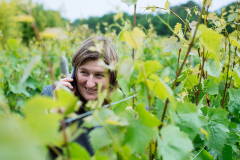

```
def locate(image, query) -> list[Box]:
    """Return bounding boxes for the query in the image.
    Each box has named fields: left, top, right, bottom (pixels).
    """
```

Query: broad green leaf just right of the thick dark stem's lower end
left=173, top=102, right=207, bottom=140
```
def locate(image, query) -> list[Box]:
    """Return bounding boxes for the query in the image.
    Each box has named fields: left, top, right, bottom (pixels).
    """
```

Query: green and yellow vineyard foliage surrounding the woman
left=0, top=0, right=240, bottom=160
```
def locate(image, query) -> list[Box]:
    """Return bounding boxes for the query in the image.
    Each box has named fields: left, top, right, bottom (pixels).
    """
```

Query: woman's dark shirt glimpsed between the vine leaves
left=40, top=85, right=93, bottom=157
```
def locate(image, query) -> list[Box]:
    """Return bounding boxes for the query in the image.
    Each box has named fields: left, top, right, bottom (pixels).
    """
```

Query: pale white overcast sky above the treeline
left=32, top=0, right=237, bottom=21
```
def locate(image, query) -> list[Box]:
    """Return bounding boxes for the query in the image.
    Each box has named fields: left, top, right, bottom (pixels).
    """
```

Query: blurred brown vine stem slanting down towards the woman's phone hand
left=27, top=7, right=55, bottom=88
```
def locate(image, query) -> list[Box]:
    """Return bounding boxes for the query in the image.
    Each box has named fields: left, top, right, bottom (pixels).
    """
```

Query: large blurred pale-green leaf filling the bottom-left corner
left=0, top=115, right=47, bottom=160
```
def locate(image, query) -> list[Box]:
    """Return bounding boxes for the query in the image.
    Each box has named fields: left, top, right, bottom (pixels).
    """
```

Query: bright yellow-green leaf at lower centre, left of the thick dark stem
left=136, top=104, right=161, bottom=127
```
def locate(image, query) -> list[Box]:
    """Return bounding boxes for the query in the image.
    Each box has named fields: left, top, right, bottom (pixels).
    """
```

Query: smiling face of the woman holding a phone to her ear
left=76, top=59, right=109, bottom=101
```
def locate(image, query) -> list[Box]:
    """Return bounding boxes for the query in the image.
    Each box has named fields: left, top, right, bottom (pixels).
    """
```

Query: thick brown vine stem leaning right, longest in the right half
left=158, top=0, right=206, bottom=129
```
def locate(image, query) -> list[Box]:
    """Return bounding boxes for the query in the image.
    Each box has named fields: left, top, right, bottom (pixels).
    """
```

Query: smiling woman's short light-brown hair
left=72, top=36, right=119, bottom=92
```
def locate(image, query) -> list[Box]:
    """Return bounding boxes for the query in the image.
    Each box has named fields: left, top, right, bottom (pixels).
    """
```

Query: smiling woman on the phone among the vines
left=41, top=36, right=119, bottom=155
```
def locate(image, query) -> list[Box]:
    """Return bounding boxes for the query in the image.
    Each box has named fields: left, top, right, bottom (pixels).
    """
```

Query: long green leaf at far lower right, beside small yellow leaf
left=205, top=108, right=229, bottom=152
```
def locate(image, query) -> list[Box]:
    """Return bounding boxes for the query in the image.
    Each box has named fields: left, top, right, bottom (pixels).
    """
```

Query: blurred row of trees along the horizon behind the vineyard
left=0, top=0, right=236, bottom=45
